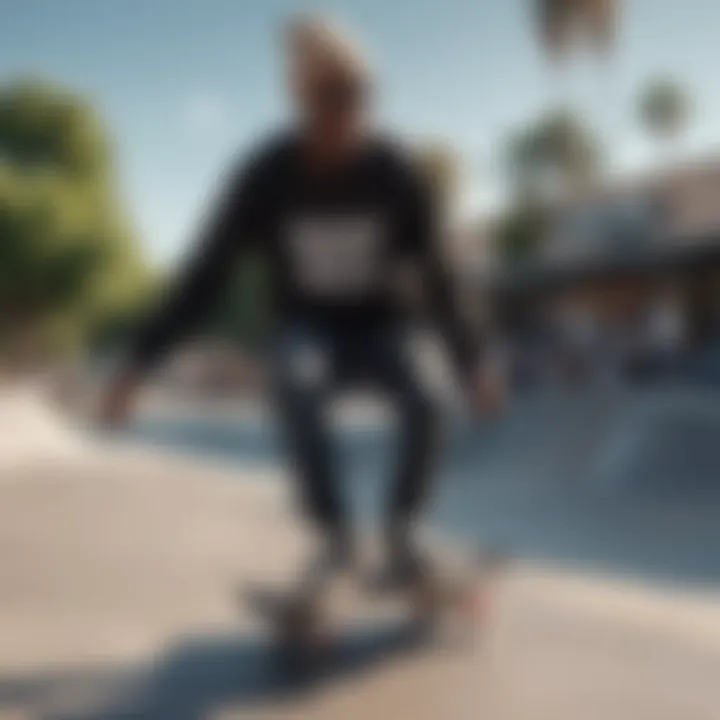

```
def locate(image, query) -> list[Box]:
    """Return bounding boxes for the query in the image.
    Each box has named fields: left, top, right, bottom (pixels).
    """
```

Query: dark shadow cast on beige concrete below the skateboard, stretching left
left=0, top=621, right=436, bottom=720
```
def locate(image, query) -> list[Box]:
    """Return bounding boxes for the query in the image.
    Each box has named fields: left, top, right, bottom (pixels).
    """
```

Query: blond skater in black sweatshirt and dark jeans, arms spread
left=103, top=19, right=500, bottom=596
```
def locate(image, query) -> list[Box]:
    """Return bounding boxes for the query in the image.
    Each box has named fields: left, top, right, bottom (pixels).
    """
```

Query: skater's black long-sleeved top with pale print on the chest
left=132, top=132, right=476, bottom=371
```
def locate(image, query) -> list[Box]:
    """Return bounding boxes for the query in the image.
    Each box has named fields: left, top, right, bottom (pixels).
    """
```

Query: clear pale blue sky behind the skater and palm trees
left=0, top=0, right=720, bottom=262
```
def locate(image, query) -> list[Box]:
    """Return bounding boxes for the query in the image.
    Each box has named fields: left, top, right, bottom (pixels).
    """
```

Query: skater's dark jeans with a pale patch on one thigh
left=275, top=320, right=438, bottom=536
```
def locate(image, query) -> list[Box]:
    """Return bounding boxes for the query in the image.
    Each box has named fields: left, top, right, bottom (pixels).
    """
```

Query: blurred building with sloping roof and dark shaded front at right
left=464, top=158, right=720, bottom=386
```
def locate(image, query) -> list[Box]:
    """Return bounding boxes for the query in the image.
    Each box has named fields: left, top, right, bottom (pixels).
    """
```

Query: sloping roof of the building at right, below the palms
left=464, top=157, right=720, bottom=289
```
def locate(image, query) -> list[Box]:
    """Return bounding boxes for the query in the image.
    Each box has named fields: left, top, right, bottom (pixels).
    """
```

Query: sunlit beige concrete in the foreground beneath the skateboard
left=0, top=449, right=720, bottom=720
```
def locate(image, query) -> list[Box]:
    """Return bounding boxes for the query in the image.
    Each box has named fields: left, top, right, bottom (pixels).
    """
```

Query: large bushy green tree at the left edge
left=0, top=81, right=150, bottom=362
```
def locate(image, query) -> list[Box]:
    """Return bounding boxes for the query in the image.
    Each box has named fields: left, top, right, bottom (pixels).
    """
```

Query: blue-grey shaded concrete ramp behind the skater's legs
left=129, top=386, right=720, bottom=584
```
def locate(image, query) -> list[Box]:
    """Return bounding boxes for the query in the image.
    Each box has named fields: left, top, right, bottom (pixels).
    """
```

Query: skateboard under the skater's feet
left=243, top=549, right=507, bottom=667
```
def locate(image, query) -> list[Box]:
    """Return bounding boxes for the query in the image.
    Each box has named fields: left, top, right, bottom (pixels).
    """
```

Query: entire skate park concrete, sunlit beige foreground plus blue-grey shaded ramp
left=0, top=389, right=720, bottom=720
